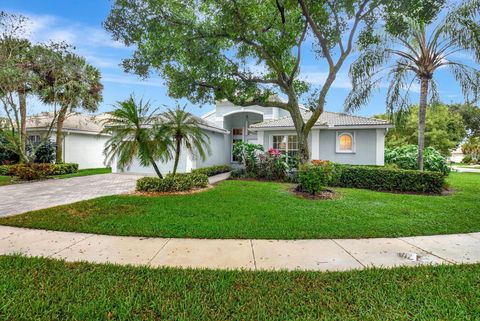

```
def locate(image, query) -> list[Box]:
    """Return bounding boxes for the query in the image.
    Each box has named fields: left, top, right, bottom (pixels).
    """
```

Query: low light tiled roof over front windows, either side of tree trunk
left=250, top=111, right=393, bottom=128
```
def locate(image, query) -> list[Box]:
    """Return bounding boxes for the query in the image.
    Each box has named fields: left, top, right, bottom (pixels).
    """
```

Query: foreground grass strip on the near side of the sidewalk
left=0, top=256, right=480, bottom=320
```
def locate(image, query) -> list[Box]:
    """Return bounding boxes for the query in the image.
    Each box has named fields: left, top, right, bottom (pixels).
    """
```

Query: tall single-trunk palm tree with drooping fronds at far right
left=345, top=0, right=480, bottom=170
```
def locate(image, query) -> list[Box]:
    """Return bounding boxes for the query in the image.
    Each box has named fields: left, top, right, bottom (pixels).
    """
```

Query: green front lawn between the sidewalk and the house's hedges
left=0, top=173, right=480, bottom=239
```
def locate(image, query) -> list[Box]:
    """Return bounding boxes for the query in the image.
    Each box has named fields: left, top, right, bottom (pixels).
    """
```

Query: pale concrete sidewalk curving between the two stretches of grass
left=0, top=226, right=480, bottom=271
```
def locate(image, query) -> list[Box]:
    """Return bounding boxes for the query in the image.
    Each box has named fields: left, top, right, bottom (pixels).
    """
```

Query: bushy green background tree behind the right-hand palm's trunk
left=376, top=104, right=466, bottom=156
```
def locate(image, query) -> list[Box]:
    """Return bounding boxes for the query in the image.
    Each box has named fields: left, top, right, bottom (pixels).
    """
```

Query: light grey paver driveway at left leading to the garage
left=0, top=174, right=140, bottom=216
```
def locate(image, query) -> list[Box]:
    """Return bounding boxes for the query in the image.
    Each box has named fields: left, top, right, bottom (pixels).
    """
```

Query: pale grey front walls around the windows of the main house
left=258, top=128, right=386, bottom=165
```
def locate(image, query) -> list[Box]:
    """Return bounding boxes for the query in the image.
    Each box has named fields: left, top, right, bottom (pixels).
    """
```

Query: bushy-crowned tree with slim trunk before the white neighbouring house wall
left=41, top=51, right=103, bottom=163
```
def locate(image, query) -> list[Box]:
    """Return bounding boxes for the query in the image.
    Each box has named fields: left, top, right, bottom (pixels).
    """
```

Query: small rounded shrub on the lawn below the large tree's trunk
left=298, top=161, right=333, bottom=195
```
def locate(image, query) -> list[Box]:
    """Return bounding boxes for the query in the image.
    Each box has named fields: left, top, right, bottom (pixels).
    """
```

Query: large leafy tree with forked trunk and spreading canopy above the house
left=104, top=0, right=432, bottom=161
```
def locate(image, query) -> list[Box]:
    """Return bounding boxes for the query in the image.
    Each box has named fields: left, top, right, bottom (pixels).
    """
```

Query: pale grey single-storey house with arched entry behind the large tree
left=113, top=101, right=393, bottom=174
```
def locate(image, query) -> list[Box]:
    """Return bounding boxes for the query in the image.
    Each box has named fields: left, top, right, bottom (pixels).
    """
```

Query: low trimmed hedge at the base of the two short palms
left=137, top=173, right=208, bottom=192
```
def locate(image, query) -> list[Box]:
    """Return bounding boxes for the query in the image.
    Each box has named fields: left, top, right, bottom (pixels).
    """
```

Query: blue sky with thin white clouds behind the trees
left=0, top=0, right=472, bottom=116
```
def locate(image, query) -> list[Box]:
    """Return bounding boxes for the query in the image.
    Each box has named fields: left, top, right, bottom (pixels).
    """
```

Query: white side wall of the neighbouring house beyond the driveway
left=63, top=133, right=108, bottom=169
